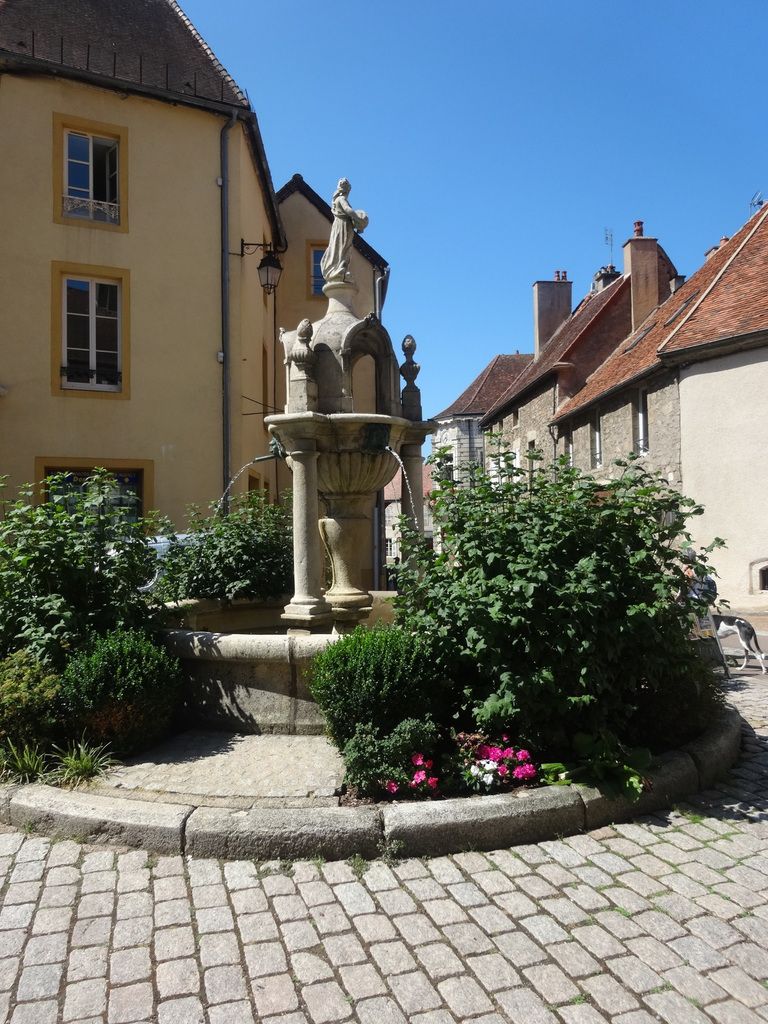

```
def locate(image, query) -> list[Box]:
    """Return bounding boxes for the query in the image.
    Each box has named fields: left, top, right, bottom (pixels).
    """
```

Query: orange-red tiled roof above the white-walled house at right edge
left=555, top=206, right=768, bottom=420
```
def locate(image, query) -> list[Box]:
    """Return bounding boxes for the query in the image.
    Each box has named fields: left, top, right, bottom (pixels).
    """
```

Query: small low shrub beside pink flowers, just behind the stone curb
left=343, top=718, right=437, bottom=796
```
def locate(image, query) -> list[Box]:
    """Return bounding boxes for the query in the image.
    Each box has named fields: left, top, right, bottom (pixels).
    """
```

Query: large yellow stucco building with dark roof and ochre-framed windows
left=0, top=0, right=286, bottom=523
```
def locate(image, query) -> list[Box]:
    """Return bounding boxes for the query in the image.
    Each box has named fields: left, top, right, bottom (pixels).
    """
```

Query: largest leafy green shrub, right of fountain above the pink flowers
left=395, top=451, right=719, bottom=759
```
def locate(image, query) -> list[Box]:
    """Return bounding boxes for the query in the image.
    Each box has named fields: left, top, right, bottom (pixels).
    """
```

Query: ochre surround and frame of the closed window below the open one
left=51, top=260, right=130, bottom=399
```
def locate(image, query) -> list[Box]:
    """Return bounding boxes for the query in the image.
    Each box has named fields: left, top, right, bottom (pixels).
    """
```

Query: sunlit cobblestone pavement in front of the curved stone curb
left=0, top=670, right=768, bottom=1024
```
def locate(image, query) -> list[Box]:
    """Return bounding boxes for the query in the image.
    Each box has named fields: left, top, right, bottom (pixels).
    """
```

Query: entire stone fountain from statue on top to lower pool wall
left=168, top=178, right=436, bottom=734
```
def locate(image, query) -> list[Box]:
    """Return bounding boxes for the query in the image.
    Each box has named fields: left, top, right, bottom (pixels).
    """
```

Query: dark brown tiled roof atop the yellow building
left=0, top=0, right=249, bottom=109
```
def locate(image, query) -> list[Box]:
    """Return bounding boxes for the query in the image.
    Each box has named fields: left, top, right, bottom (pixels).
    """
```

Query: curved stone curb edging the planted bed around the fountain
left=0, top=709, right=742, bottom=860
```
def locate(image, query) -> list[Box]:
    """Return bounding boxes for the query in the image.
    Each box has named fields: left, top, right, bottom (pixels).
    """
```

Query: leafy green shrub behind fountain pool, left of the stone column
left=156, top=490, right=293, bottom=601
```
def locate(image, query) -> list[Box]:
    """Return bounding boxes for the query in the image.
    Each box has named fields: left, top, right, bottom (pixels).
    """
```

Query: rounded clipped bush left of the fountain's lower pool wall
left=61, top=630, right=181, bottom=753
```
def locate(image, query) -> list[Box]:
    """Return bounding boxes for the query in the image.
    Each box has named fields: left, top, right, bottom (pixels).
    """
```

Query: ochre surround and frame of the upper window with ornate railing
left=52, top=113, right=128, bottom=232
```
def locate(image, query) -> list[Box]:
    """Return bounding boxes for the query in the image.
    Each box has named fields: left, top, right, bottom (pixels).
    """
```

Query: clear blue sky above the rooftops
left=181, top=0, right=768, bottom=415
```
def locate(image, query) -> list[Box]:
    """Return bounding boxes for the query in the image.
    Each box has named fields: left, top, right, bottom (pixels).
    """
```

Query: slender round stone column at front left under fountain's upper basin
left=283, top=440, right=331, bottom=628
